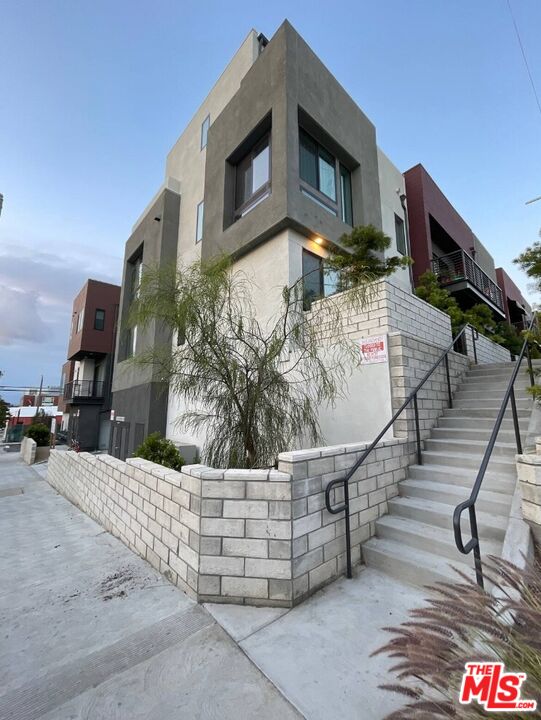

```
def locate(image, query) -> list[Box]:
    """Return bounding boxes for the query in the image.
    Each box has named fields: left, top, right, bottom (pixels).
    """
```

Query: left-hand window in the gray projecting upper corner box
left=235, top=134, right=271, bottom=218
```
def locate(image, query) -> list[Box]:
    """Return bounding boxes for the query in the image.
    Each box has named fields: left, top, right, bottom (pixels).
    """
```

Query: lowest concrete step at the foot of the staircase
left=362, top=538, right=475, bottom=587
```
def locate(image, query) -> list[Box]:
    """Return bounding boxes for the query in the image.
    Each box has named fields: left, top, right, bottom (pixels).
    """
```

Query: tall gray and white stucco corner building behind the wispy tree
left=113, top=21, right=411, bottom=462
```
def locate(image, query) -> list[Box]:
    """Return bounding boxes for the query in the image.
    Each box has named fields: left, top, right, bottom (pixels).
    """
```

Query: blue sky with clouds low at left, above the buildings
left=0, top=0, right=541, bottom=402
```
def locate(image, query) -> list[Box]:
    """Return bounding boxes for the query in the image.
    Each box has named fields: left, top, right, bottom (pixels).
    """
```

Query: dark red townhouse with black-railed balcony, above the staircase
left=404, top=164, right=506, bottom=321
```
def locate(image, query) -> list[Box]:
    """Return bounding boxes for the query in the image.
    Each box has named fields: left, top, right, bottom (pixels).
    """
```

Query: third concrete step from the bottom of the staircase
left=388, top=495, right=508, bottom=542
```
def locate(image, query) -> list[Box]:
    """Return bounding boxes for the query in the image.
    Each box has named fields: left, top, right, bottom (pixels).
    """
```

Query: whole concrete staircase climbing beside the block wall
left=362, top=362, right=532, bottom=585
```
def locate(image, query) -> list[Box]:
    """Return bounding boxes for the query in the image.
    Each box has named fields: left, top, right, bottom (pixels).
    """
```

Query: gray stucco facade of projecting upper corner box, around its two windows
left=202, top=21, right=381, bottom=258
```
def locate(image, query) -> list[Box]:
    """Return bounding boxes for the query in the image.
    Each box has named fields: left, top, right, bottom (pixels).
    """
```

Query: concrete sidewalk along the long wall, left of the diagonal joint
left=0, top=456, right=302, bottom=720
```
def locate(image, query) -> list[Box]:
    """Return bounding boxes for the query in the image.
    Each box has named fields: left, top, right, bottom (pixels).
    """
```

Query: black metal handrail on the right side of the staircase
left=453, top=315, right=536, bottom=587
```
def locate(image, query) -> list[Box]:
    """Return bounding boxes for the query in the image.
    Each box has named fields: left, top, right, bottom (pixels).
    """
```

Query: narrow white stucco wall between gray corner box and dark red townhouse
left=378, top=148, right=411, bottom=291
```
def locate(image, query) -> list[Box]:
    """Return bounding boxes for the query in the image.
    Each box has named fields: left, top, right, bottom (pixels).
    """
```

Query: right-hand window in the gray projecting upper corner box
left=299, top=128, right=353, bottom=225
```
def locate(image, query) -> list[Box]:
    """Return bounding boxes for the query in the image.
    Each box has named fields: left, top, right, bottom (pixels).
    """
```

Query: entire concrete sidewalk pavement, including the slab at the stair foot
left=0, top=453, right=424, bottom=720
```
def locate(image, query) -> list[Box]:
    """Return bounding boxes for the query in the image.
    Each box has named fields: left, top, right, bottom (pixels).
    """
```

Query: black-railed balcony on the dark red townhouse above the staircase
left=432, top=250, right=505, bottom=315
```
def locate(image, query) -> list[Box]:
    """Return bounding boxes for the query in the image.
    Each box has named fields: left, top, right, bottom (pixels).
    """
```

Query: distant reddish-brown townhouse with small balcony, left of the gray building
left=60, top=280, right=120, bottom=451
